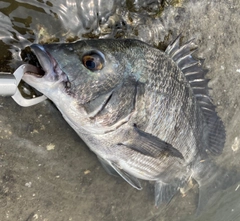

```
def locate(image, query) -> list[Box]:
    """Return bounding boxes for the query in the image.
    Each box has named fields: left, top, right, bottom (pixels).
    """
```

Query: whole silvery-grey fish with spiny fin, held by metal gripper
left=23, top=36, right=228, bottom=210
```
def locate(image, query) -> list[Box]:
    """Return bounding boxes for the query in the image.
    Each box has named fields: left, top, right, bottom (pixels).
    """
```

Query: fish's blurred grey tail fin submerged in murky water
left=194, top=160, right=240, bottom=215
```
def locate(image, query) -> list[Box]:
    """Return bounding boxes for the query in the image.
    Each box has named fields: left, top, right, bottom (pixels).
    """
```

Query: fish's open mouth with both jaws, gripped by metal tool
left=23, top=44, right=68, bottom=96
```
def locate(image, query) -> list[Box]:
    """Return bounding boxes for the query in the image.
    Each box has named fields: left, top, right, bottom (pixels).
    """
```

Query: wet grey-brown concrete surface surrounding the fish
left=0, top=0, right=240, bottom=221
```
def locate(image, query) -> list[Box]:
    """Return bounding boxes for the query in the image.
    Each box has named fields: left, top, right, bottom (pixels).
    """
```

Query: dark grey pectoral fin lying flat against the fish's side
left=118, top=127, right=183, bottom=159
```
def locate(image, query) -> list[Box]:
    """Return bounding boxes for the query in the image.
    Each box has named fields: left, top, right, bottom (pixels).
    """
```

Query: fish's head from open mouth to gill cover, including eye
left=23, top=39, right=144, bottom=133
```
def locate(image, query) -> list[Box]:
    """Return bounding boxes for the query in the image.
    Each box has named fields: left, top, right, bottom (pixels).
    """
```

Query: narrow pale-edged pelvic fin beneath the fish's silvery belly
left=98, top=157, right=142, bottom=190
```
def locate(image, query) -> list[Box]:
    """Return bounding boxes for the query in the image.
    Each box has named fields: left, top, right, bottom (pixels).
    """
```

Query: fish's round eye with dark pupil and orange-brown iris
left=82, top=52, right=104, bottom=71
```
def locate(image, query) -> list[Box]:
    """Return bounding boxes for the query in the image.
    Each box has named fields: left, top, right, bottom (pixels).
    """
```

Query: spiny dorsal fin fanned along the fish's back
left=165, top=35, right=226, bottom=154
